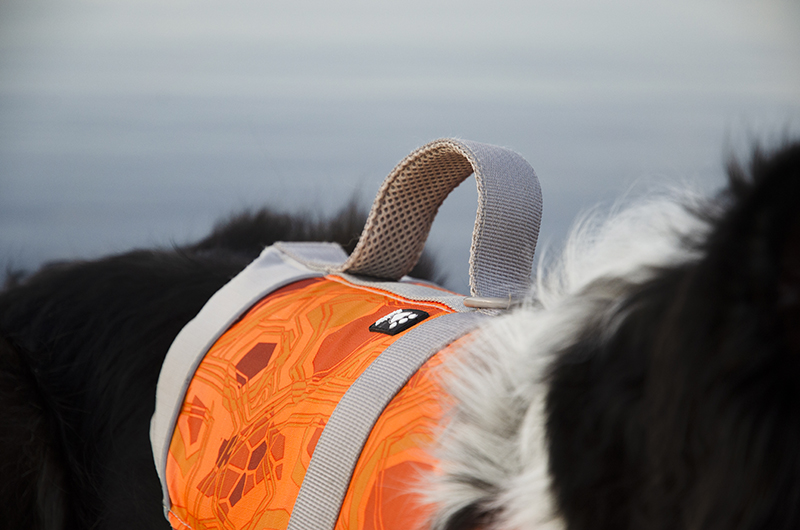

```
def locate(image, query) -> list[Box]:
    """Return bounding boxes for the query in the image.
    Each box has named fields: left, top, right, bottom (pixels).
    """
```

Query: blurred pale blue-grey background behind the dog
left=0, top=0, right=800, bottom=291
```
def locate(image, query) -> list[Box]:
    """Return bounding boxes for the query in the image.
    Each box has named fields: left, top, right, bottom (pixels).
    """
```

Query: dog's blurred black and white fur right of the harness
left=435, top=144, right=800, bottom=530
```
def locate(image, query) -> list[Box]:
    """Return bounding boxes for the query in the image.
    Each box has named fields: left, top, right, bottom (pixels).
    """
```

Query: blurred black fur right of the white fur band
left=547, top=138, right=800, bottom=530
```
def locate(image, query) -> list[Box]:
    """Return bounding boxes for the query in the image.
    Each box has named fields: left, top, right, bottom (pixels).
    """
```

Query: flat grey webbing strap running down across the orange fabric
left=287, top=313, right=482, bottom=530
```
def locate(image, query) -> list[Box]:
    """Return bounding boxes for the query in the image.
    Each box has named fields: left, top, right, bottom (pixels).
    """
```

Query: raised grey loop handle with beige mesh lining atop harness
left=333, top=139, right=542, bottom=298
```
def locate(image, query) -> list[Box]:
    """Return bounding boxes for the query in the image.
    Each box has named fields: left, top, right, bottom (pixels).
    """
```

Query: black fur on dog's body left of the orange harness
left=0, top=204, right=433, bottom=529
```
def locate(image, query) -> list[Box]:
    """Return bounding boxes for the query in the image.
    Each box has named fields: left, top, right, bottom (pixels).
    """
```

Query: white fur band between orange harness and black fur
left=427, top=191, right=707, bottom=530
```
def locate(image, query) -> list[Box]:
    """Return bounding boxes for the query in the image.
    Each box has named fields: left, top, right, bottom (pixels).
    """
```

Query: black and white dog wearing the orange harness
left=0, top=143, right=800, bottom=530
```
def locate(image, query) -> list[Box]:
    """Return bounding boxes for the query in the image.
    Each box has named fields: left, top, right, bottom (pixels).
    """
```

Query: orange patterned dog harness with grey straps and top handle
left=151, top=139, right=541, bottom=530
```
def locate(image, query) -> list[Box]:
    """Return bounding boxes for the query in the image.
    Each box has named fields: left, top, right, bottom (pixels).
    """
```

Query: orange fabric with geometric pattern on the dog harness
left=167, top=276, right=460, bottom=530
